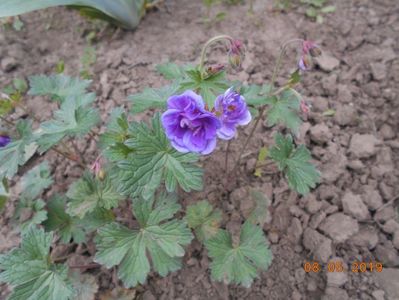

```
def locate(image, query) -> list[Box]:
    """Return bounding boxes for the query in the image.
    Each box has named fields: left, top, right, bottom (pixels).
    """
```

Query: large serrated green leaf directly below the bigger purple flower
left=113, top=114, right=202, bottom=199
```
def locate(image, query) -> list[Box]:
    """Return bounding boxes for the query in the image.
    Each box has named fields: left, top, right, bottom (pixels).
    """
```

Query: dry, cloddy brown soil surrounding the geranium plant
left=0, top=0, right=399, bottom=300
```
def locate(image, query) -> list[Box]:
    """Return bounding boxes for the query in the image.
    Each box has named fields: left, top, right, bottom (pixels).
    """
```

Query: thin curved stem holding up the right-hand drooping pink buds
left=233, top=39, right=304, bottom=172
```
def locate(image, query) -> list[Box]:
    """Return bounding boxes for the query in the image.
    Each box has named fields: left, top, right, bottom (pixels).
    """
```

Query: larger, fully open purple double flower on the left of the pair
left=162, top=91, right=221, bottom=155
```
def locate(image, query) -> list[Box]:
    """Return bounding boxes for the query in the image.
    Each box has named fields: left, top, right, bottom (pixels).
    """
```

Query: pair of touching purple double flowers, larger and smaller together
left=162, top=88, right=251, bottom=155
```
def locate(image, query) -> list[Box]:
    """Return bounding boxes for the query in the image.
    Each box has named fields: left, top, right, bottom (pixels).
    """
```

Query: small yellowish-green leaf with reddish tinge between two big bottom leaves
left=186, top=200, right=222, bottom=241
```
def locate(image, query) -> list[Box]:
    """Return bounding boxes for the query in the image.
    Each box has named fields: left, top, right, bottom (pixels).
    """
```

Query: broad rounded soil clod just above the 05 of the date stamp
left=319, top=213, right=359, bottom=243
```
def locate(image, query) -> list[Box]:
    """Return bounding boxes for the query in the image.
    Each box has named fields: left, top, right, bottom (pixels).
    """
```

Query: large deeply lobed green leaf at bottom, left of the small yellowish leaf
left=95, top=195, right=193, bottom=287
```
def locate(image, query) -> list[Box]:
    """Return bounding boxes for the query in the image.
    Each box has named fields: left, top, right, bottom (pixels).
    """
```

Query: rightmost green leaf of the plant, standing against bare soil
left=270, top=133, right=320, bottom=195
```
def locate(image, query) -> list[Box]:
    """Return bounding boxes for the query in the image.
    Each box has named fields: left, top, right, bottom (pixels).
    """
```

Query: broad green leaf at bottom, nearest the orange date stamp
left=205, top=222, right=272, bottom=287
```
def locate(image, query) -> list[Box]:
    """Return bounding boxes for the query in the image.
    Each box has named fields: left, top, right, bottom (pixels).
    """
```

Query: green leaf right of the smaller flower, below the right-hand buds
left=267, top=89, right=302, bottom=134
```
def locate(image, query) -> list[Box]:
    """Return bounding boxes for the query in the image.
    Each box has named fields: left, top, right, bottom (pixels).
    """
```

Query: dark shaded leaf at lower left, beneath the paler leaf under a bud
left=43, top=195, right=115, bottom=244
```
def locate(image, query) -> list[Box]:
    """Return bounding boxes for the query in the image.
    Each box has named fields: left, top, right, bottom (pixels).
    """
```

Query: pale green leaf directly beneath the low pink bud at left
left=66, top=172, right=123, bottom=218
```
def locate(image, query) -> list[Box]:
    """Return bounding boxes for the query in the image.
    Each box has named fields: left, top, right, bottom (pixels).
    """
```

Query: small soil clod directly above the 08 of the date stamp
left=303, top=227, right=332, bottom=263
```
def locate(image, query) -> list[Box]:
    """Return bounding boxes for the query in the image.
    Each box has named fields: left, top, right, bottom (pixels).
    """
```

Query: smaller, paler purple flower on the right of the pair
left=215, top=88, right=252, bottom=140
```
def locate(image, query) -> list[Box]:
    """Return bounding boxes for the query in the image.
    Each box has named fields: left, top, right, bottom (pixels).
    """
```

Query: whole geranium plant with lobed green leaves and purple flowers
left=0, top=35, right=320, bottom=300
